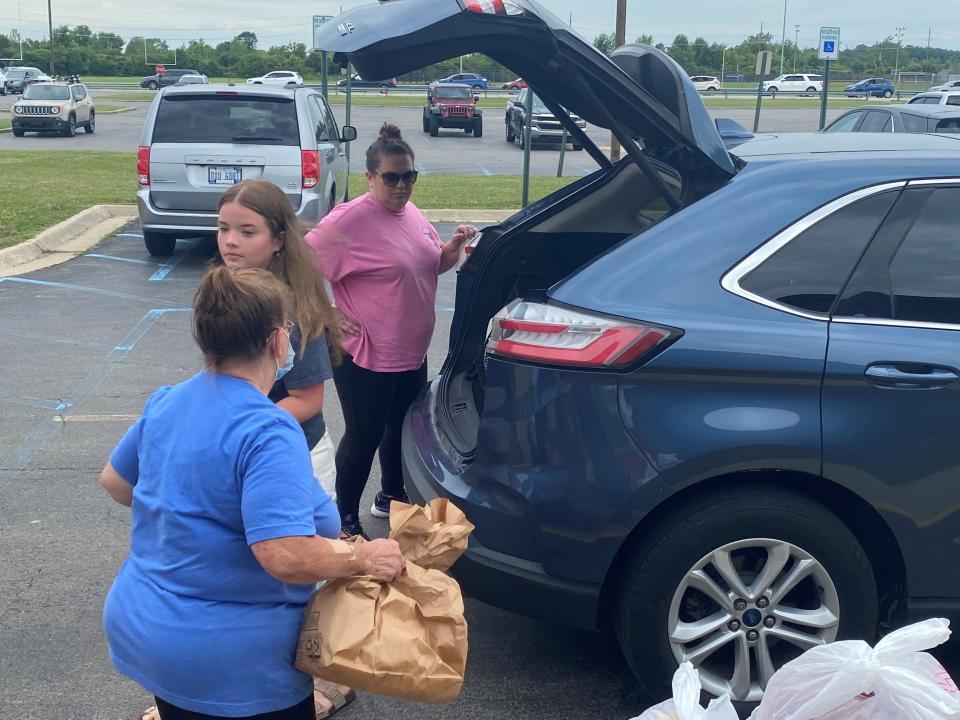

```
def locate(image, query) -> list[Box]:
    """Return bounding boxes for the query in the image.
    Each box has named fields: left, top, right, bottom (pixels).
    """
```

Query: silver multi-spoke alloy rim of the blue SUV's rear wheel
left=667, top=538, right=840, bottom=702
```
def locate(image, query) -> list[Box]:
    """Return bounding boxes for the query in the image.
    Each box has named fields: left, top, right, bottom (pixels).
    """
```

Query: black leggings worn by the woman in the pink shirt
left=333, top=355, right=427, bottom=520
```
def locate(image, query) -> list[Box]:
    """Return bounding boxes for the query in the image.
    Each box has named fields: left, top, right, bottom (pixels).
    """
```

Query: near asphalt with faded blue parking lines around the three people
left=0, top=223, right=644, bottom=720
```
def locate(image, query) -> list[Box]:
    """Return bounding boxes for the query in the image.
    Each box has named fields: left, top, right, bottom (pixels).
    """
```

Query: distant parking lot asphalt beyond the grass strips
left=0, top=90, right=843, bottom=176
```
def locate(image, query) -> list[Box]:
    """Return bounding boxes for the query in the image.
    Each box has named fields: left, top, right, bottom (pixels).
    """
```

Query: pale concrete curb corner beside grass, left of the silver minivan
left=0, top=205, right=137, bottom=276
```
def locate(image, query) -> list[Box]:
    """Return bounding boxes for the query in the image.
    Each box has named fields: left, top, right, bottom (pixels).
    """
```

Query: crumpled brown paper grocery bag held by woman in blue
left=296, top=500, right=473, bottom=703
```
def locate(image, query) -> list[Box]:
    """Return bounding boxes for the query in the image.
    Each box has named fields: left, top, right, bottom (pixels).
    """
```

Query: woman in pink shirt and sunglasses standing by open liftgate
left=307, top=123, right=477, bottom=536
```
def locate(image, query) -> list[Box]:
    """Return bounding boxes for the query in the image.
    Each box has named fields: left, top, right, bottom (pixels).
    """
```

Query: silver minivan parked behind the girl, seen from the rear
left=137, top=84, right=356, bottom=255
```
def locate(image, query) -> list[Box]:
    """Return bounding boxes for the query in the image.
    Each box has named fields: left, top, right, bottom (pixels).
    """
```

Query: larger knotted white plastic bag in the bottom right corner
left=750, top=618, right=960, bottom=720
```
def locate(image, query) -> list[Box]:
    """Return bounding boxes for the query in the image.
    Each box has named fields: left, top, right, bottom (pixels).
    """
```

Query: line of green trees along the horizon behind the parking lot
left=0, top=25, right=960, bottom=84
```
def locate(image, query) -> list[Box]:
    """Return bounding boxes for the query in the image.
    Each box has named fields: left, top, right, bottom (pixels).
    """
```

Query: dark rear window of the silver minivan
left=153, top=95, right=300, bottom=145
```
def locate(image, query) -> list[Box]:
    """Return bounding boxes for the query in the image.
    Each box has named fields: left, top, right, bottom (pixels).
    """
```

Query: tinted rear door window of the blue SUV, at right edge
left=890, top=188, right=960, bottom=324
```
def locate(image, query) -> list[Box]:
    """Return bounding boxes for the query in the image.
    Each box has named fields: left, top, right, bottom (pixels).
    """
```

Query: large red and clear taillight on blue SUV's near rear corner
left=487, top=299, right=681, bottom=368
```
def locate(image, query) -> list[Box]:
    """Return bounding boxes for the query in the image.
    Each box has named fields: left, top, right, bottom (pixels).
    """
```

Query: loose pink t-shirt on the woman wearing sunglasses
left=307, top=193, right=442, bottom=372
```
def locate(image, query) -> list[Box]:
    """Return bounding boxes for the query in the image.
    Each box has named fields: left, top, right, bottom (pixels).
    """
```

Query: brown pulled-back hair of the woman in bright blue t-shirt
left=193, top=265, right=293, bottom=370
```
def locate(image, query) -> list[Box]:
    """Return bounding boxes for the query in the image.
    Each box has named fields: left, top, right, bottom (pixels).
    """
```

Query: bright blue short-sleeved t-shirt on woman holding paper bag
left=103, top=372, right=340, bottom=717
